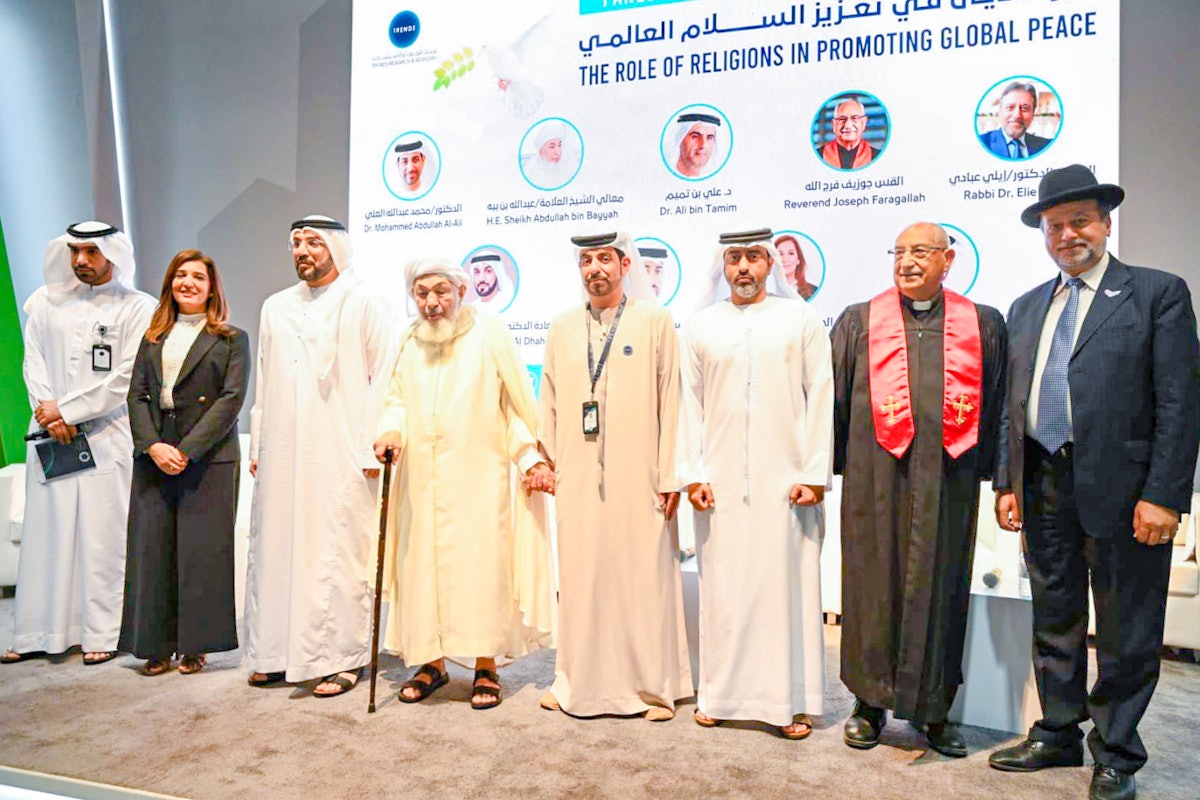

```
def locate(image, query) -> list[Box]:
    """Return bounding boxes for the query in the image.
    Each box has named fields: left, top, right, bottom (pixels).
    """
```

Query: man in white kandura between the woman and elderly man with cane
left=246, top=216, right=392, bottom=697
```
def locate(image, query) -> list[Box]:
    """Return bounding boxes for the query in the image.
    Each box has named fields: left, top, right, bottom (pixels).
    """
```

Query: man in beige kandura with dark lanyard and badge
left=540, top=233, right=692, bottom=721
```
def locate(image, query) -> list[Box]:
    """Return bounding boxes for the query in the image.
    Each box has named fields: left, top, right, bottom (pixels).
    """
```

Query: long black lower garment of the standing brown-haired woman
left=118, top=456, right=238, bottom=658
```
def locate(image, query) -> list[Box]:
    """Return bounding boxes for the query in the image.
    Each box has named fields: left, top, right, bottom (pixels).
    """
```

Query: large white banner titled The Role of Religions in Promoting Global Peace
left=350, top=0, right=1120, bottom=383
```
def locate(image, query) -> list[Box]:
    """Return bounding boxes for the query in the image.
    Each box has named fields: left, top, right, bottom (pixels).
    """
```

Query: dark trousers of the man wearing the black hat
left=1025, top=439, right=1171, bottom=772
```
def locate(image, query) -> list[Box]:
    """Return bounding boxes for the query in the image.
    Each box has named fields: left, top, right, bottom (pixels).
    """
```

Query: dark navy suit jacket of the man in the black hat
left=996, top=257, right=1200, bottom=537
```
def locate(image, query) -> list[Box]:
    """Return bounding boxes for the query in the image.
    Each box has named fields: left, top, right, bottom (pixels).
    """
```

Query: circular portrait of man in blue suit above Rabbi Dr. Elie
left=976, top=76, right=1062, bottom=161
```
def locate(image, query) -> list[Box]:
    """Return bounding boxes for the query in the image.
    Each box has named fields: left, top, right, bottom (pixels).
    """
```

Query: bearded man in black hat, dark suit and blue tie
left=989, top=164, right=1200, bottom=800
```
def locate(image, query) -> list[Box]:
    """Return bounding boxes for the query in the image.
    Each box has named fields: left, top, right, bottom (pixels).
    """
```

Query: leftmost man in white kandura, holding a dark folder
left=0, top=222, right=155, bottom=666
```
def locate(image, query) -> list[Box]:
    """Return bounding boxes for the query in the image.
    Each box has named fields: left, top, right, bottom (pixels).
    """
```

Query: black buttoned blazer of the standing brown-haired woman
left=128, top=327, right=250, bottom=463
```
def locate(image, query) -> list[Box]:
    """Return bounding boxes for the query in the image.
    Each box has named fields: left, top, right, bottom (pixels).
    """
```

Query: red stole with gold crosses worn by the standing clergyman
left=866, top=289, right=983, bottom=458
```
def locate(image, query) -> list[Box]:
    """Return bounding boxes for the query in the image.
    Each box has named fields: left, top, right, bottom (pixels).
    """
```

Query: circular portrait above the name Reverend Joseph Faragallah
left=812, top=91, right=892, bottom=172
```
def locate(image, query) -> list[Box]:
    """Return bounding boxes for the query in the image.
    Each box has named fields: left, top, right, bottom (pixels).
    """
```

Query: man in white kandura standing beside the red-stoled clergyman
left=679, top=229, right=833, bottom=739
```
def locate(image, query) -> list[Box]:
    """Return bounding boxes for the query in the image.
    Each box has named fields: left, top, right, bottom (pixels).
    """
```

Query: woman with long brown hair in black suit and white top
left=119, top=249, right=250, bottom=675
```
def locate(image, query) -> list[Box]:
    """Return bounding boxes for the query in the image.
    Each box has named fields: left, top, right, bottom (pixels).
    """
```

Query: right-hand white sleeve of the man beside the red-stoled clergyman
left=796, top=313, right=833, bottom=489
